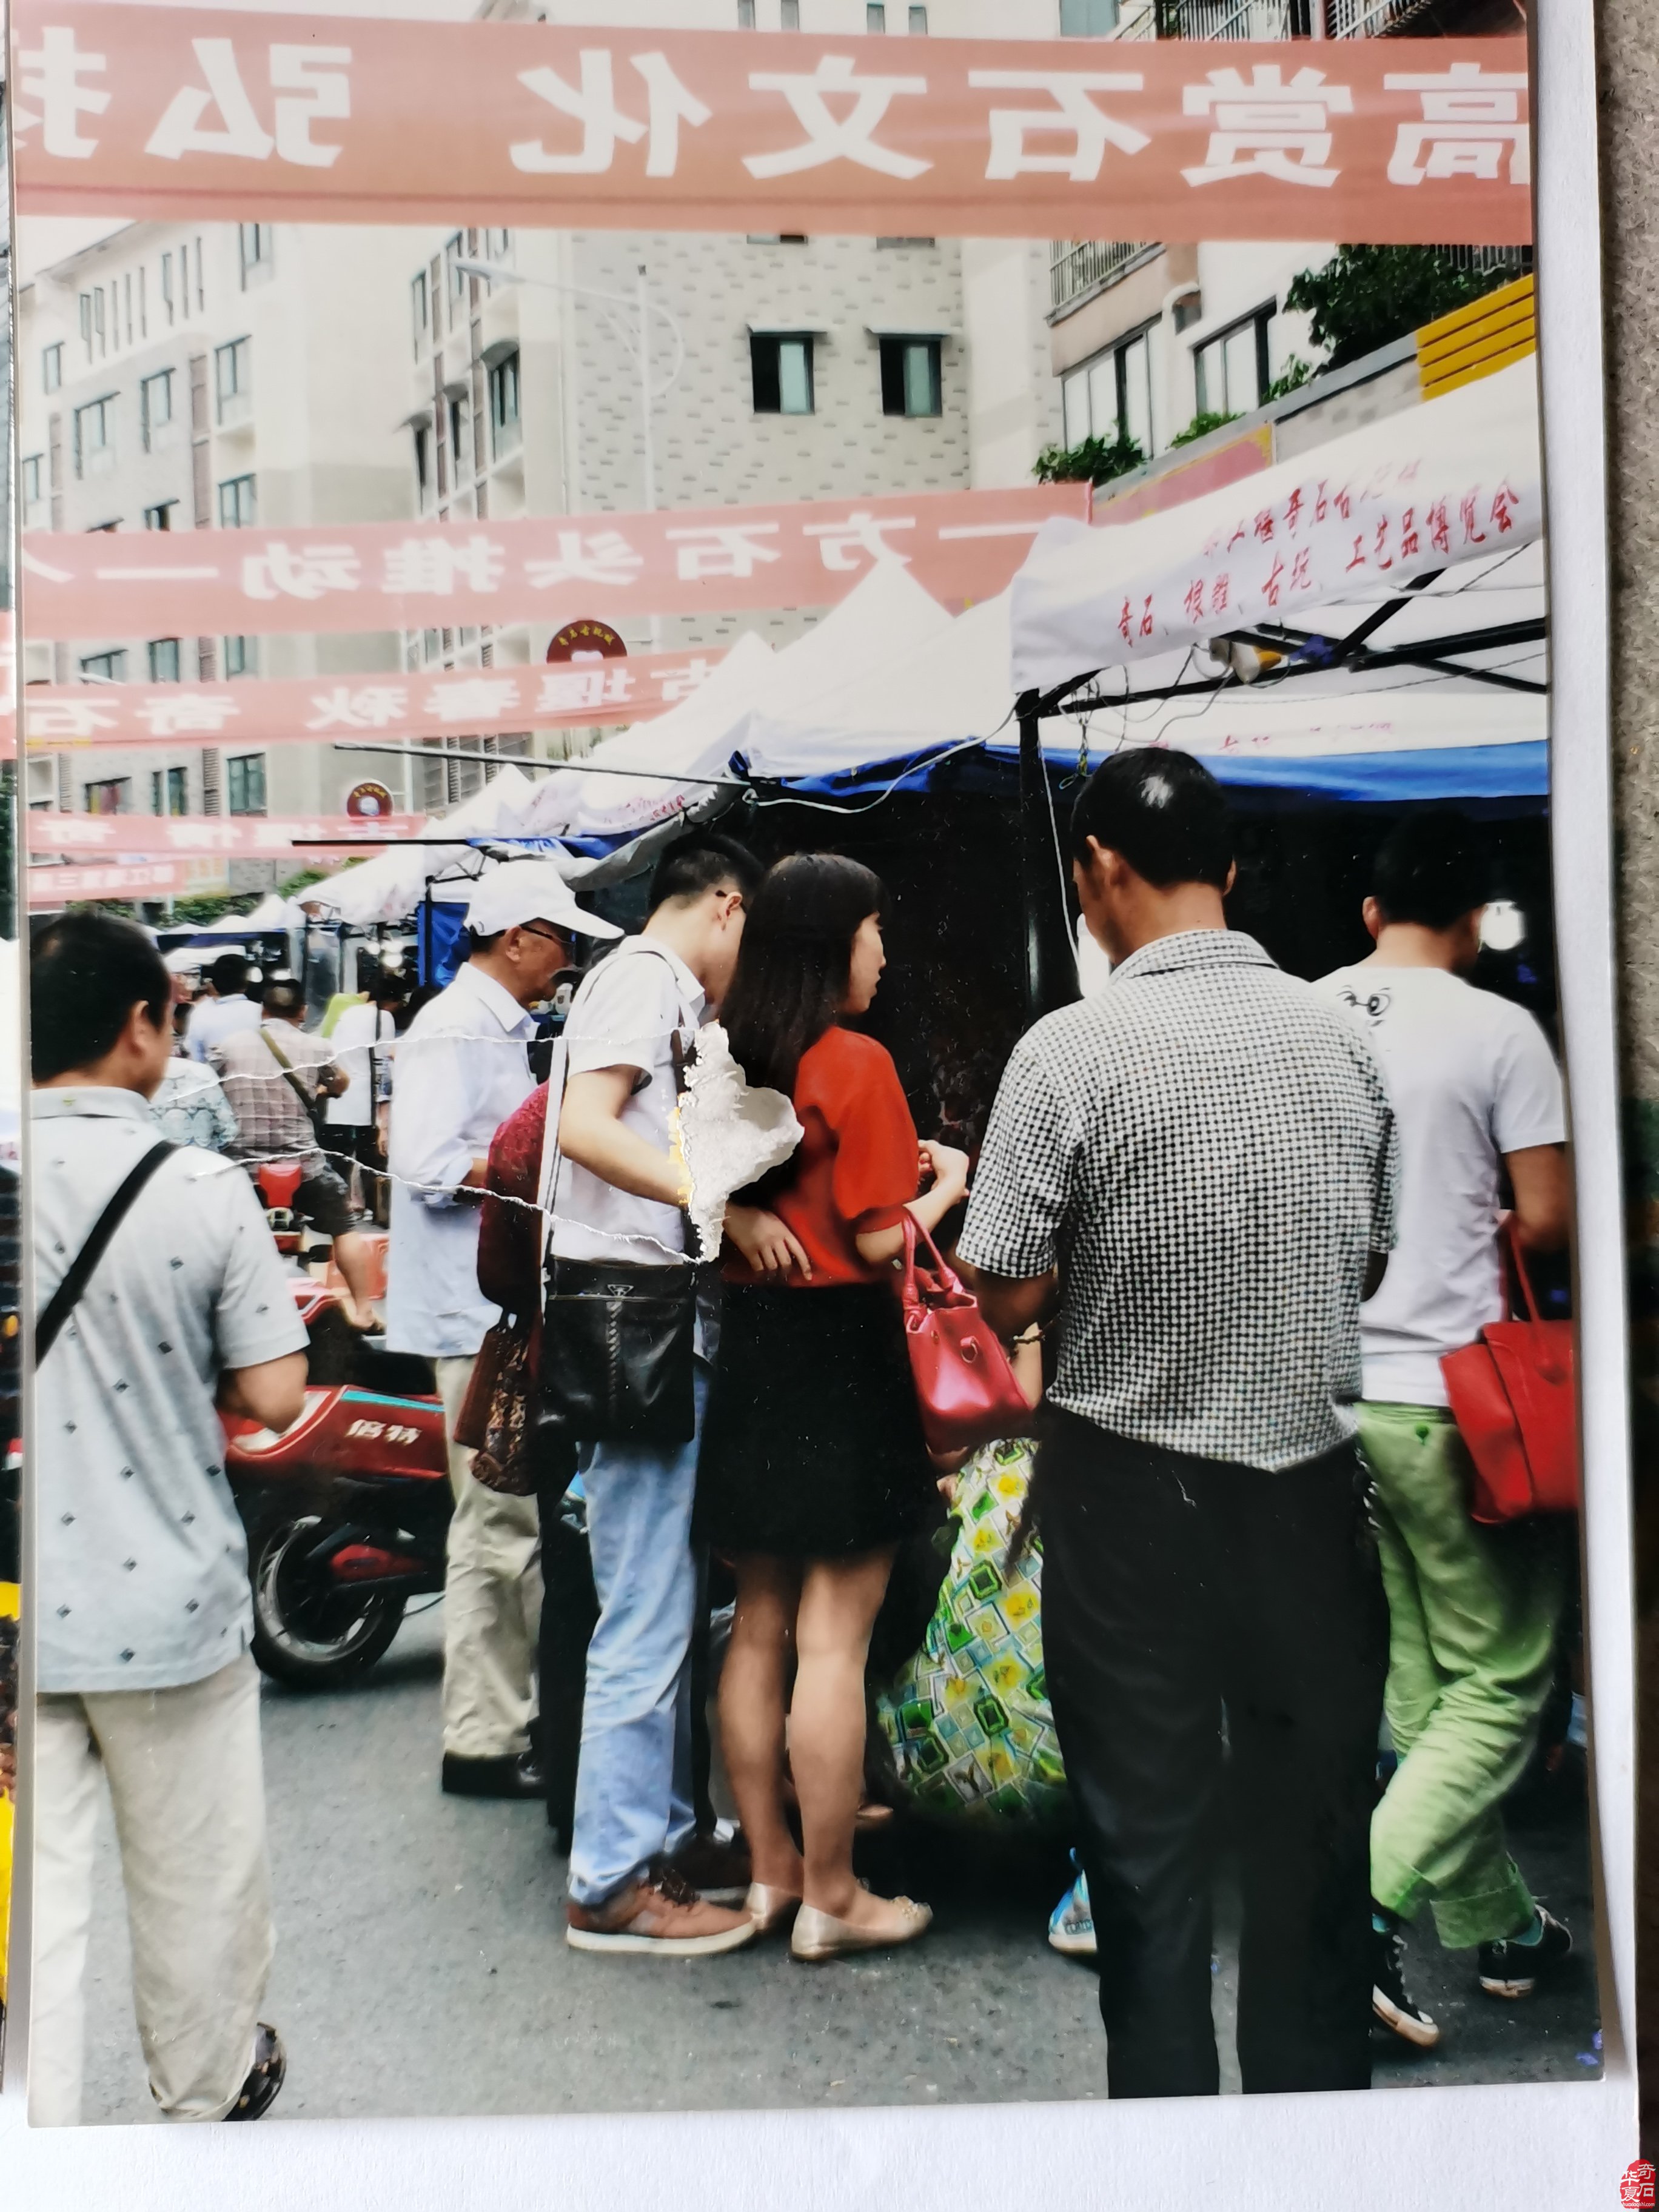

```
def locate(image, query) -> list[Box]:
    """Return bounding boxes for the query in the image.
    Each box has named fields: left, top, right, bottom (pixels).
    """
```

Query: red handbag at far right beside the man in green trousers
left=1440, top=1215, right=1580, bottom=1524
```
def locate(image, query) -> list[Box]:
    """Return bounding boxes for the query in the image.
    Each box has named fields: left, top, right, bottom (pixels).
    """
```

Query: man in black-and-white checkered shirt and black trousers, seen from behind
left=958, top=748, right=1396, bottom=2097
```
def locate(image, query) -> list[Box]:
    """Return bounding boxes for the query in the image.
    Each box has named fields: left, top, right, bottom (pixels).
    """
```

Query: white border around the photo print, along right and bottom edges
left=0, top=0, right=1637, bottom=2212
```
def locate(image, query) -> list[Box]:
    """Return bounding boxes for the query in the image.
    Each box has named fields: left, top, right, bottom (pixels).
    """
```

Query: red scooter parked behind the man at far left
left=226, top=1274, right=451, bottom=1690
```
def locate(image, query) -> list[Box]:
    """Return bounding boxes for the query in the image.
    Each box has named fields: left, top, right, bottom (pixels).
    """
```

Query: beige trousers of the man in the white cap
left=436, top=1361, right=542, bottom=1758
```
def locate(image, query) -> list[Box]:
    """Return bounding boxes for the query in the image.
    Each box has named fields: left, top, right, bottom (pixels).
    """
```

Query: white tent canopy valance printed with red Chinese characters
left=1011, top=356, right=1544, bottom=692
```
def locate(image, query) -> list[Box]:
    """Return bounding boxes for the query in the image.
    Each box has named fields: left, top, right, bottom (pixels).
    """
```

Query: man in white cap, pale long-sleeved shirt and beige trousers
left=385, top=860, right=622, bottom=1798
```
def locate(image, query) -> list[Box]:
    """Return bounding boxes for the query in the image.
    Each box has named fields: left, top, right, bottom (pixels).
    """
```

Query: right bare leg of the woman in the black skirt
left=789, top=1546, right=894, bottom=1926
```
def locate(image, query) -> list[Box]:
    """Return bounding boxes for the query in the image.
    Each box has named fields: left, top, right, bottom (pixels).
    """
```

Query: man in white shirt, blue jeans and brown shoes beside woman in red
left=551, top=830, right=805, bottom=1957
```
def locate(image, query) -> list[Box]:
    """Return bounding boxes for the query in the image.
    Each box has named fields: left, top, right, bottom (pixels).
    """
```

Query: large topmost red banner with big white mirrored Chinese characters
left=11, top=0, right=1530, bottom=246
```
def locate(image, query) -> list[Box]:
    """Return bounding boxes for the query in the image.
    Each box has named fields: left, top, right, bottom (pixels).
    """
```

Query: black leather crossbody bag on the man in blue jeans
left=537, top=945, right=697, bottom=1444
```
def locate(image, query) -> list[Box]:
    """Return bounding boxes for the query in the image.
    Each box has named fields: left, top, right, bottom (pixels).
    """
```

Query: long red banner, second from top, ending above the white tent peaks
left=22, top=484, right=1088, bottom=639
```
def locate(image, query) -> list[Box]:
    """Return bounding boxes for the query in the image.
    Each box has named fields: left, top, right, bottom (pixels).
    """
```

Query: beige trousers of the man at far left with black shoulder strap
left=28, top=1657, right=272, bottom=2128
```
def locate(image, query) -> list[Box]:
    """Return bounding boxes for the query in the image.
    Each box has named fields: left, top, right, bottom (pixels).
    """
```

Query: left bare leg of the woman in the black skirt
left=719, top=1553, right=801, bottom=1898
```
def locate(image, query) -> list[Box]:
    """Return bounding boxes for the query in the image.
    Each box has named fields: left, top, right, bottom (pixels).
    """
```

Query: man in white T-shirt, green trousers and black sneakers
left=1316, top=814, right=1570, bottom=2046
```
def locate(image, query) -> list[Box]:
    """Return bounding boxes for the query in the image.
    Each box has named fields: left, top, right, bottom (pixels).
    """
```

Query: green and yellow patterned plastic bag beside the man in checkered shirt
left=876, top=1438, right=1073, bottom=1834
